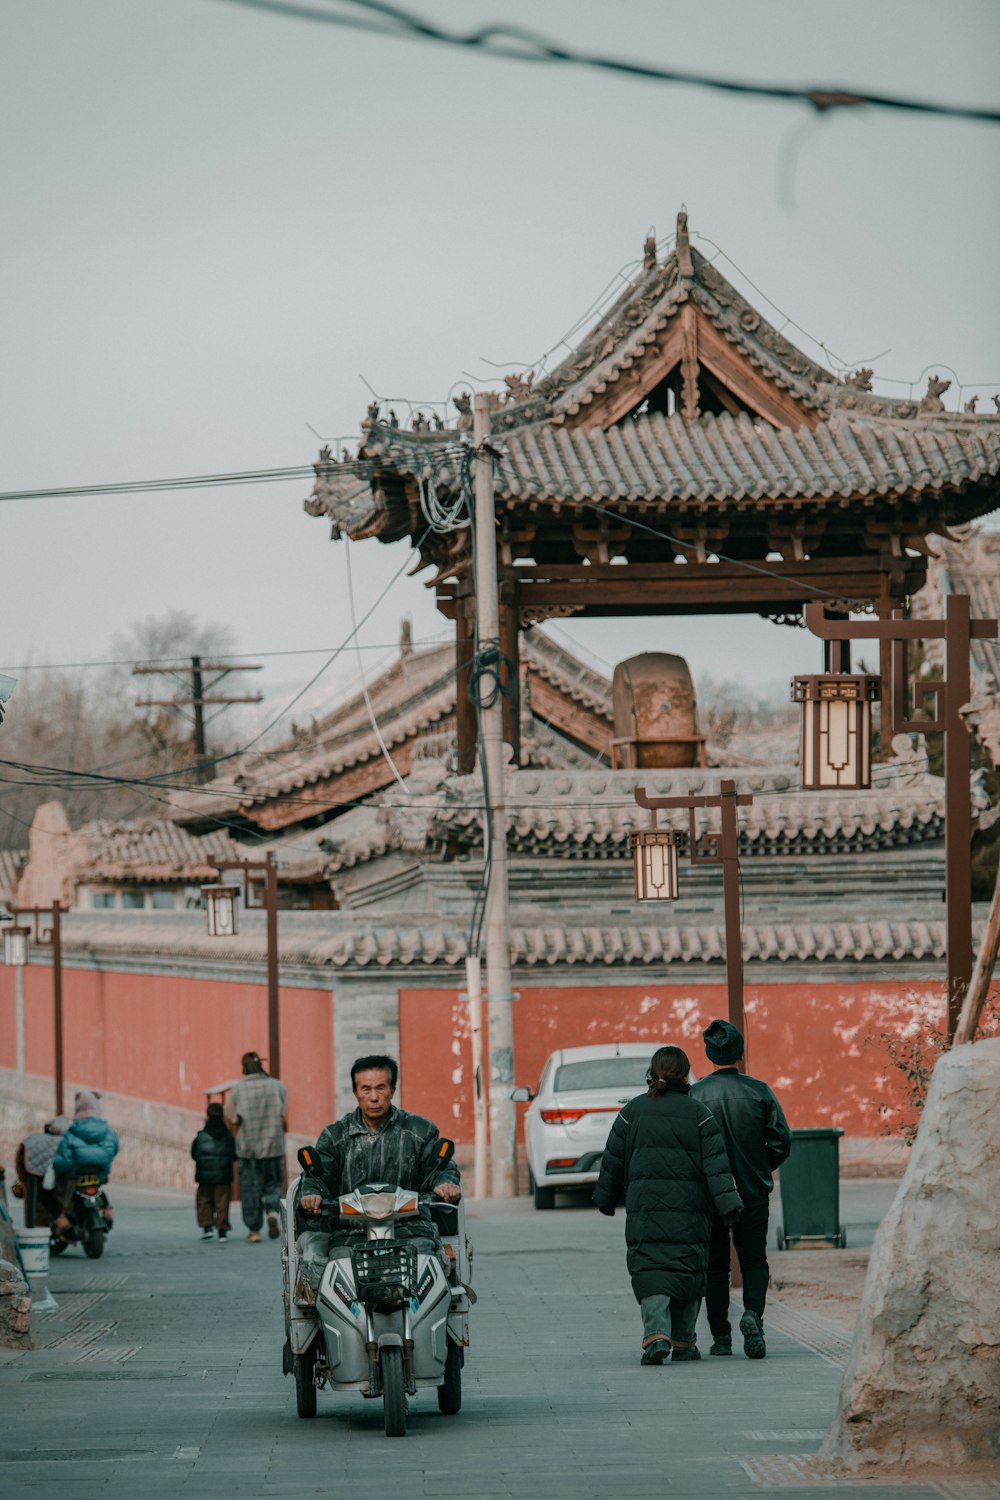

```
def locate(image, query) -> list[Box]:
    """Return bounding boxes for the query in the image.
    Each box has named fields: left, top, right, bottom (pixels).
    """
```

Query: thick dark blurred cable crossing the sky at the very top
left=212, top=0, right=1000, bottom=125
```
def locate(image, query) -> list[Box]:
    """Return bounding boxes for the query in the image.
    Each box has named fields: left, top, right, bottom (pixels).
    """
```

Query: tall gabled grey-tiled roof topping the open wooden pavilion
left=306, top=215, right=1000, bottom=587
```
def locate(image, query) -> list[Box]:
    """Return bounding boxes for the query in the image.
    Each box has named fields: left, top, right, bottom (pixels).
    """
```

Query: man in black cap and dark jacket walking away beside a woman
left=691, top=1022, right=792, bottom=1359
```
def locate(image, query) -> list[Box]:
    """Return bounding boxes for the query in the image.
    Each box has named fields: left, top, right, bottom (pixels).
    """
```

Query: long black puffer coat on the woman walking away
left=594, top=1083, right=742, bottom=1302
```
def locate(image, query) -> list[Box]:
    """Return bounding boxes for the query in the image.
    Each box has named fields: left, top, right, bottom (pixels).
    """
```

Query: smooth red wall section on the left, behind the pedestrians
left=0, top=965, right=334, bottom=1136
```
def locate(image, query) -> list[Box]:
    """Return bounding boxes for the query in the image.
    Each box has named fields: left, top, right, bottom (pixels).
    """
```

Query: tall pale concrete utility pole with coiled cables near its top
left=472, top=395, right=516, bottom=1199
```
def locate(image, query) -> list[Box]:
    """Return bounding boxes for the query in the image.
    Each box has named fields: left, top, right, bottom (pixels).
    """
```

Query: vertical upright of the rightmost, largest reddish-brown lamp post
left=943, top=594, right=972, bottom=1043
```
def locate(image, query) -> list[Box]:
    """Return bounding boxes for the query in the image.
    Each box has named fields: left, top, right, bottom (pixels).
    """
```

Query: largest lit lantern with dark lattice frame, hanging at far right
left=792, top=672, right=882, bottom=792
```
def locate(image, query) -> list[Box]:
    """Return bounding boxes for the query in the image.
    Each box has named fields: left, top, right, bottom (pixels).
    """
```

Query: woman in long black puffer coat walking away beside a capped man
left=594, top=1047, right=744, bottom=1365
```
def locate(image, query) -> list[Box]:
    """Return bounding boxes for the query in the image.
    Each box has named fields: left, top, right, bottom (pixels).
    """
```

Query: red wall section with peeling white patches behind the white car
left=399, top=983, right=943, bottom=1142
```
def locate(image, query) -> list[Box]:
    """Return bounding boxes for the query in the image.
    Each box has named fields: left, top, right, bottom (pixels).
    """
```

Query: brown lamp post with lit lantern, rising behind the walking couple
left=630, top=780, right=753, bottom=1035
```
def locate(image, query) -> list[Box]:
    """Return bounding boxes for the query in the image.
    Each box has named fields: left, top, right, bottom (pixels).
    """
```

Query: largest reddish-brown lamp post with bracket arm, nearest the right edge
left=793, top=594, right=997, bottom=1041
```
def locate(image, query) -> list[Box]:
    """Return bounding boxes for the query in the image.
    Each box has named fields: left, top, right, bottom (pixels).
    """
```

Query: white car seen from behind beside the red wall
left=511, top=1041, right=658, bottom=1209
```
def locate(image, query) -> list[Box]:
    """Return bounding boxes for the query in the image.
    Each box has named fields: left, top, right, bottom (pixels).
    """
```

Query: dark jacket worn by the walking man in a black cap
left=691, top=1068, right=792, bottom=1206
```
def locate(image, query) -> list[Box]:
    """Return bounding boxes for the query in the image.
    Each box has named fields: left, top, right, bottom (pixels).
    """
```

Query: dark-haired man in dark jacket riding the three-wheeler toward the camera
left=297, top=1055, right=462, bottom=1286
